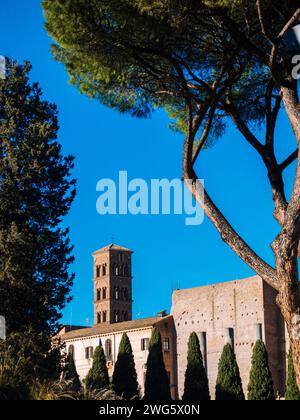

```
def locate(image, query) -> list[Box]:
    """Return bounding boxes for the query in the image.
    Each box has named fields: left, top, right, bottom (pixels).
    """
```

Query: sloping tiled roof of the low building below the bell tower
left=61, top=316, right=167, bottom=341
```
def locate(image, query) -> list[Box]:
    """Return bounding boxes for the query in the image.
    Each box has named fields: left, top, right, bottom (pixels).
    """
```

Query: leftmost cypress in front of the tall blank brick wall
left=182, top=333, right=210, bottom=401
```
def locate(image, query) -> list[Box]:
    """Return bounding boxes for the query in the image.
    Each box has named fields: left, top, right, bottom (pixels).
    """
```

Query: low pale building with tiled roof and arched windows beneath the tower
left=60, top=316, right=177, bottom=399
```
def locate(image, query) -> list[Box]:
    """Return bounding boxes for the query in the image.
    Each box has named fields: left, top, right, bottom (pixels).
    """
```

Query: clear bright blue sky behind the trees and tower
left=0, top=0, right=295, bottom=326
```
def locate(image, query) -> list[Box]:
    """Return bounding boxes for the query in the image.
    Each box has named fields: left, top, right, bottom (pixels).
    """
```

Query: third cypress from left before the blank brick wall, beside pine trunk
left=248, top=340, right=275, bottom=401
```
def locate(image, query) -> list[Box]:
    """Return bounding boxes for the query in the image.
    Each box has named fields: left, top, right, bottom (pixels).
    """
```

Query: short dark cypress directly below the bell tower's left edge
left=85, top=346, right=109, bottom=391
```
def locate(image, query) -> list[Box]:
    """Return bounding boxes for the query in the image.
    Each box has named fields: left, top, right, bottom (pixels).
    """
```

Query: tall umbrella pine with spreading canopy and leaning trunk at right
left=43, top=0, right=300, bottom=386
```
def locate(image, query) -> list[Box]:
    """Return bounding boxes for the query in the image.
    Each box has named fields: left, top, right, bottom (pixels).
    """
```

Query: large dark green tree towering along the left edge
left=0, top=60, right=75, bottom=375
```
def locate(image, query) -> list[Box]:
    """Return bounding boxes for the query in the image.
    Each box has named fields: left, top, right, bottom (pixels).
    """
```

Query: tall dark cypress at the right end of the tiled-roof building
left=144, top=328, right=171, bottom=401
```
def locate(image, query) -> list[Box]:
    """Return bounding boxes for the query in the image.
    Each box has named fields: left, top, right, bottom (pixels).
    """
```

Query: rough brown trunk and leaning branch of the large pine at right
left=183, top=83, right=300, bottom=388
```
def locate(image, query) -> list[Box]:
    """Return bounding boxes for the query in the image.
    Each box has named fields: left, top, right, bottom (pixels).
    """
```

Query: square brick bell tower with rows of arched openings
left=93, top=244, right=133, bottom=325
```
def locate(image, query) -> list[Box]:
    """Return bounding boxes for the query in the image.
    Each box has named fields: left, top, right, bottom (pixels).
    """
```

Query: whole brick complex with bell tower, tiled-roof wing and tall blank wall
left=59, top=245, right=286, bottom=399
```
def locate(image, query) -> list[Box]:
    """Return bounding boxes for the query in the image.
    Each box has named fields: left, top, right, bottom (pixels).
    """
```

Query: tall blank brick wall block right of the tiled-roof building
left=172, top=277, right=286, bottom=398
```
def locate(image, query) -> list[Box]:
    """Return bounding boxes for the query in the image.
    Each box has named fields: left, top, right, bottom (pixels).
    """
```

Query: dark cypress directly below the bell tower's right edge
left=112, top=334, right=139, bottom=400
